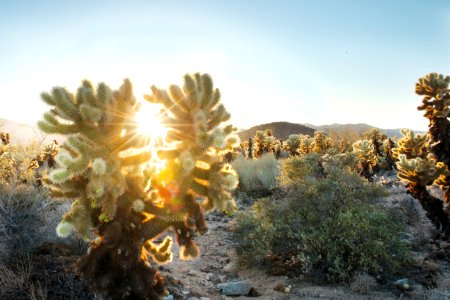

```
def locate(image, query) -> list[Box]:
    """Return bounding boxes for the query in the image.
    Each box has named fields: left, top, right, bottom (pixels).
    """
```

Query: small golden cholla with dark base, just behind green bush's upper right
left=352, top=140, right=377, bottom=181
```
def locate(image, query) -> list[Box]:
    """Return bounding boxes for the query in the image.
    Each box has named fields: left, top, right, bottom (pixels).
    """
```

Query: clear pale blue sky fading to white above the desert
left=0, top=0, right=450, bottom=130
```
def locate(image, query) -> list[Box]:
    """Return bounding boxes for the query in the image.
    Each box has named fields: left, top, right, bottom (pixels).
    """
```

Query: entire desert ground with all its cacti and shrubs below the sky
left=0, top=73, right=450, bottom=299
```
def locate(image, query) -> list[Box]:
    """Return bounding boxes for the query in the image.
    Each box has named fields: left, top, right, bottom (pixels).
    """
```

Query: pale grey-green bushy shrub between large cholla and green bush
left=232, top=153, right=280, bottom=191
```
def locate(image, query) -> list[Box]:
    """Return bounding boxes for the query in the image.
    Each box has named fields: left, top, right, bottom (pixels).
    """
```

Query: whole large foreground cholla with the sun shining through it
left=39, top=74, right=238, bottom=299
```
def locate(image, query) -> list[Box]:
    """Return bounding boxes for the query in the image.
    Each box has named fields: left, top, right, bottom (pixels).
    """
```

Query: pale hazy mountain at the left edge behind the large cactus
left=0, top=118, right=63, bottom=145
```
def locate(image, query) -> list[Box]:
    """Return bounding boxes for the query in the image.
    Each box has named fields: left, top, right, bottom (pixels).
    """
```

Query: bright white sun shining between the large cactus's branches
left=135, top=102, right=168, bottom=139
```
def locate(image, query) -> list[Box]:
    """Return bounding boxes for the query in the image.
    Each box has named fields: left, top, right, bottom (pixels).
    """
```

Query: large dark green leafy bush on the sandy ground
left=235, top=156, right=409, bottom=282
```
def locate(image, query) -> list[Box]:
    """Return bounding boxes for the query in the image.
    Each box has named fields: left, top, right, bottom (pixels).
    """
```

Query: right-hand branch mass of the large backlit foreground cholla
left=145, top=73, right=239, bottom=214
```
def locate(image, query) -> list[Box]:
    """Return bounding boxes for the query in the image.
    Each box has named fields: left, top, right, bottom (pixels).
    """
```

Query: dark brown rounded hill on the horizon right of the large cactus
left=238, top=122, right=315, bottom=141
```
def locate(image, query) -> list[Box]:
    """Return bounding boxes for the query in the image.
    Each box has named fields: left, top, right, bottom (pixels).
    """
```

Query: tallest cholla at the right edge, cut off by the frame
left=416, top=73, right=450, bottom=205
